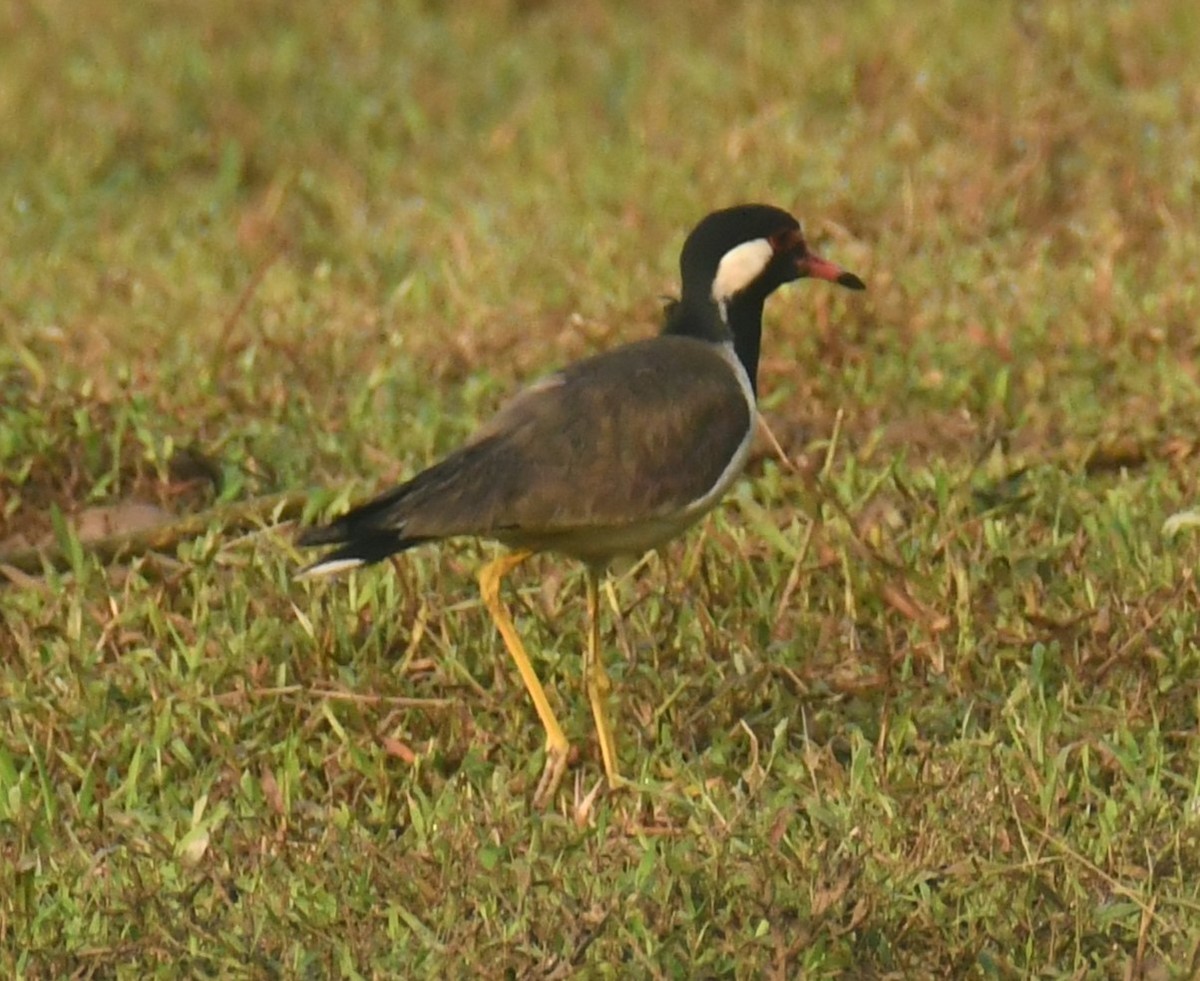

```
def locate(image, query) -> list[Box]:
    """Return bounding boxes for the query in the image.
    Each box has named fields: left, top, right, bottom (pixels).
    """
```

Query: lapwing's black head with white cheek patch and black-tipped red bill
left=679, top=204, right=864, bottom=308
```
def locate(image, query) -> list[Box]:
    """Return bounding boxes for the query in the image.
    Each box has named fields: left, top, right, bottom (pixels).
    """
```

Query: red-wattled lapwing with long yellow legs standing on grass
left=298, top=204, right=865, bottom=807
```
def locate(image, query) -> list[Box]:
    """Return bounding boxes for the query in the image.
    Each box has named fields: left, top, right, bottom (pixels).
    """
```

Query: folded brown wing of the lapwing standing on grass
left=386, top=337, right=752, bottom=538
